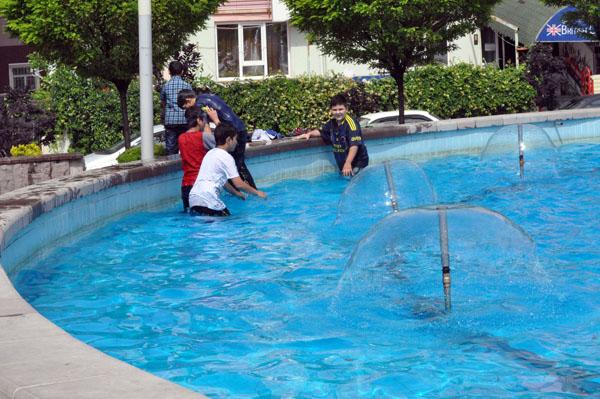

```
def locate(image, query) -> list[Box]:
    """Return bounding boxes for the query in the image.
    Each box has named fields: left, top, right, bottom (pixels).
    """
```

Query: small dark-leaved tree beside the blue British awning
left=525, top=43, right=566, bottom=110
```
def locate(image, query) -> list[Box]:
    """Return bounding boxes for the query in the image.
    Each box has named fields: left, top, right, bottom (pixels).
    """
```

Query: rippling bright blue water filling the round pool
left=13, top=144, right=600, bottom=398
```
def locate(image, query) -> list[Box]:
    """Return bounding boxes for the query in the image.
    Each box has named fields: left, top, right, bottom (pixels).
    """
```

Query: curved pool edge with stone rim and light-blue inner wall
left=0, top=109, right=600, bottom=399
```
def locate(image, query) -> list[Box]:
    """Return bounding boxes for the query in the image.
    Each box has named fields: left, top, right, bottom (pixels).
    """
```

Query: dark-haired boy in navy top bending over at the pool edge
left=177, top=90, right=256, bottom=188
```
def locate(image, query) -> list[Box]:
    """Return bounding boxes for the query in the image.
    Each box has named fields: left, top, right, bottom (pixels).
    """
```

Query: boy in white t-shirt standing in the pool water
left=190, top=123, right=267, bottom=216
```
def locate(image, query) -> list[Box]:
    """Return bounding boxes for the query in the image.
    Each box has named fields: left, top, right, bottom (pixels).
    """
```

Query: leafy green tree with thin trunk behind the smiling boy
left=284, top=0, right=500, bottom=123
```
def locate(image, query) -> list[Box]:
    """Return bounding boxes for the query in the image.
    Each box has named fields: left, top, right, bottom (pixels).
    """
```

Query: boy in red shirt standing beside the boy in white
left=177, top=107, right=215, bottom=212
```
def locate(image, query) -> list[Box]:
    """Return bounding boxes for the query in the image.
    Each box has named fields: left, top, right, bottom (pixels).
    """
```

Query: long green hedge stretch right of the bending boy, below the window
left=202, top=64, right=535, bottom=134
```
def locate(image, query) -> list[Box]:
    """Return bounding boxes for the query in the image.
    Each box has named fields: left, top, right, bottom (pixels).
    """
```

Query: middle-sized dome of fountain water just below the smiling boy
left=335, top=160, right=436, bottom=237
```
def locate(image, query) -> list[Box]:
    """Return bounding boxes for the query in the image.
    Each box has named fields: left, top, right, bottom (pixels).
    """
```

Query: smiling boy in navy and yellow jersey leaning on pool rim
left=296, top=95, right=369, bottom=176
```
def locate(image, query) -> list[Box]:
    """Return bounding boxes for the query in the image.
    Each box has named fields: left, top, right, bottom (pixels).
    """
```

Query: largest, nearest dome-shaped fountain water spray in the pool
left=334, top=206, right=547, bottom=325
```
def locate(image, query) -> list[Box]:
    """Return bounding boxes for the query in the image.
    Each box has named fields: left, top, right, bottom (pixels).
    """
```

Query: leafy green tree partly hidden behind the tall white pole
left=0, top=0, right=224, bottom=147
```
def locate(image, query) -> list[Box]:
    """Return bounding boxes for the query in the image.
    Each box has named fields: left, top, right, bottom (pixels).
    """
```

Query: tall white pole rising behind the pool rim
left=138, top=0, right=154, bottom=163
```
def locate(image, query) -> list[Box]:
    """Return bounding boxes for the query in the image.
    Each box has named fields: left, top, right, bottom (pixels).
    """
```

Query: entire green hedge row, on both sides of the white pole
left=35, top=64, right=535, bottom=154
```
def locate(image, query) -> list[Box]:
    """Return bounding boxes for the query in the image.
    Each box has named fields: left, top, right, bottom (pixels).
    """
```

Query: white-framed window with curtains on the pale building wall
left=217, top=22, right=289, bottom=79
